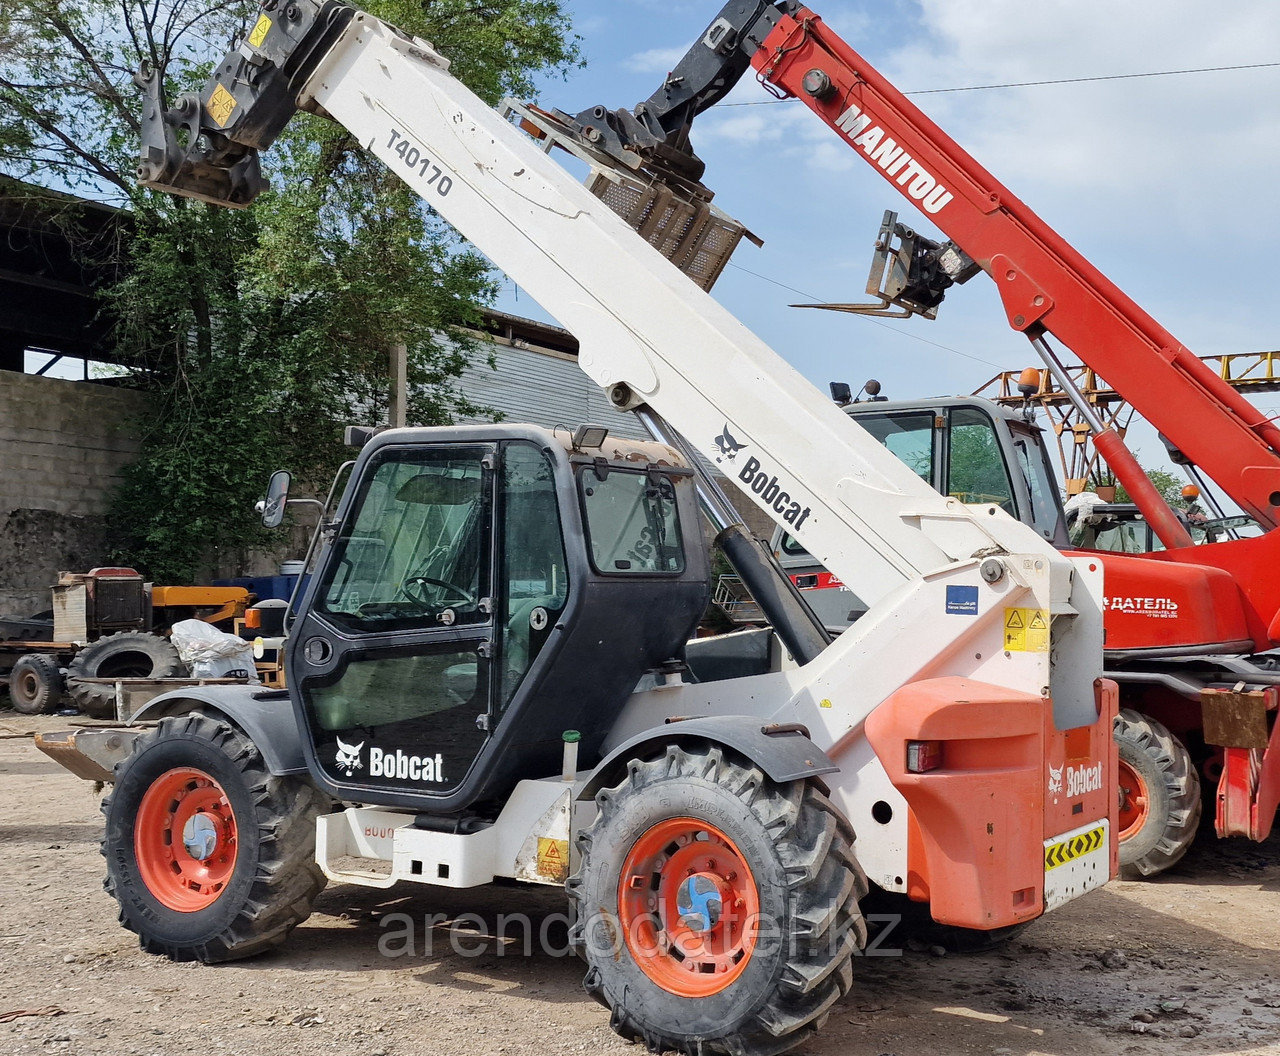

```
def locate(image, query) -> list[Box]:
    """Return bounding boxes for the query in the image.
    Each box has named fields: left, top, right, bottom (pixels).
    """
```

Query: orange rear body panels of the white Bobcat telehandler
left=865, top=676, right=1119, bottom=929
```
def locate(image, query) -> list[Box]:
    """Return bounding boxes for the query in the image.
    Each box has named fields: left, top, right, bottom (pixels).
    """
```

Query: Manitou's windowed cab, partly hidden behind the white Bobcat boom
left=772, top=394, right=1068, bottom=632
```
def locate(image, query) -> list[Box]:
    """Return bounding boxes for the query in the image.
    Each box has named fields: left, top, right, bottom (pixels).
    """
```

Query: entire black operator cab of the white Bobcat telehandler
left=285, top=425, right=709, bottom=814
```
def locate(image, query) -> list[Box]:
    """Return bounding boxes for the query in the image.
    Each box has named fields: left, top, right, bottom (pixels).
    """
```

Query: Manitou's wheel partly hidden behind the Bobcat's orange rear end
left=1115, top=708, right=1202, bottom=879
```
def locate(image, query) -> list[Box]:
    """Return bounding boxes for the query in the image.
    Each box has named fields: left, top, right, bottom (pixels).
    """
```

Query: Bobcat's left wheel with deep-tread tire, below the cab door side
left=102, top=710, right=329, bottom=963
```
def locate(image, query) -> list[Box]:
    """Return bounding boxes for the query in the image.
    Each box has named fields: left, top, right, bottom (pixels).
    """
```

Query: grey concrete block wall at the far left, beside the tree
left=0, top=371, right=145, bottom=616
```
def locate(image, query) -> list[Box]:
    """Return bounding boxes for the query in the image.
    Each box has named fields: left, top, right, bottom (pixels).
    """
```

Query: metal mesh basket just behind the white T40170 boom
left=586, top=169, right=748, bottom=289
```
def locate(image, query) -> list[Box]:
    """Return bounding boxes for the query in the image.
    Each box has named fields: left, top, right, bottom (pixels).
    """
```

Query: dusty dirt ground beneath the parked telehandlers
left=0, top=712, right=1280, bottom=1056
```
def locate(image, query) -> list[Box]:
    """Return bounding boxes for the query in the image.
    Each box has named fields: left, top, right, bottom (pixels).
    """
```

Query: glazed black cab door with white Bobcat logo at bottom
left=288, top=443, right=495, bottom=797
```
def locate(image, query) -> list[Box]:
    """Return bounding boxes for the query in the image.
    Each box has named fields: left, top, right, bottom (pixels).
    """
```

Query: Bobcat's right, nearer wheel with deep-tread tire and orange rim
left=568, top=745, right=867, bottom=1056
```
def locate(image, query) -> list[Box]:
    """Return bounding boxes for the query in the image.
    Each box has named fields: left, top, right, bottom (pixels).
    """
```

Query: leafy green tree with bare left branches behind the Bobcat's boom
left=0, top=0, right=580, bottom=581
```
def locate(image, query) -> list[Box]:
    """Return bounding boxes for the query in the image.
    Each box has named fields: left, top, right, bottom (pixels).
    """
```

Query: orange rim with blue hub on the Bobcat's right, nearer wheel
left=618, top=818, right=760, bottom=997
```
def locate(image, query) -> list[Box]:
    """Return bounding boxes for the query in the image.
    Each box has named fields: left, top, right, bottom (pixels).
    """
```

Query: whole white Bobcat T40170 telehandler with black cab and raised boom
left=37, top=0, right=1117, bottom=1053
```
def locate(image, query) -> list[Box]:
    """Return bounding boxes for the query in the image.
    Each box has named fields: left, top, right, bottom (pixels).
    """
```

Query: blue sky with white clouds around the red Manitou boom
left=488, top=0, right=1280, bottom=499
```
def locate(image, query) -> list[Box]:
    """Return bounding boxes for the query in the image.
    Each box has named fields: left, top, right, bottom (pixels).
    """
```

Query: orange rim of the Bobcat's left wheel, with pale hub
left=133, top=767, right=239, bottom=913
